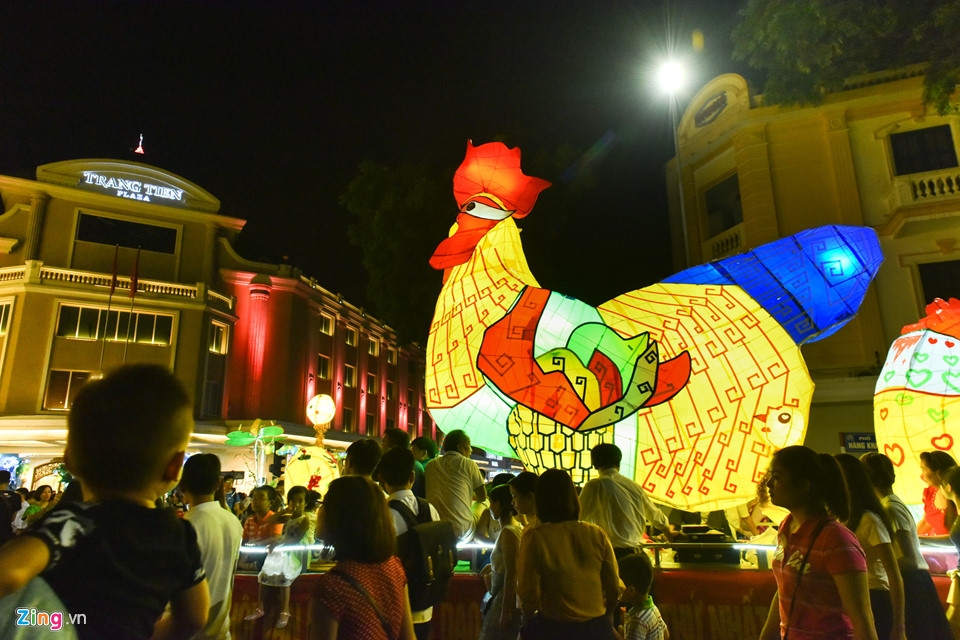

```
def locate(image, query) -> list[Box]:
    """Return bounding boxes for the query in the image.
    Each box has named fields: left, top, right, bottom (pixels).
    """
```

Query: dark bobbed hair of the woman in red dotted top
left=318, top=476, right=397, bottom=564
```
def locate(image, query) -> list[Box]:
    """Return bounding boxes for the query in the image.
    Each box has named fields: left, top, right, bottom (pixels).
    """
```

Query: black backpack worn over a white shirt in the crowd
left=390, top=498, right=458, bottom=611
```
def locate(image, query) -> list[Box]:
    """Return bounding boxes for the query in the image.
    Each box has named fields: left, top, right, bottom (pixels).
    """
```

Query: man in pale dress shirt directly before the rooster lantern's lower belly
left=580, top=443, right=676, bottom=559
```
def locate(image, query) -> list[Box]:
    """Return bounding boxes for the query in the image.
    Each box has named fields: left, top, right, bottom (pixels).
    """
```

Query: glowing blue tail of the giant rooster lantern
left=664, top=225, right=883, bottom=344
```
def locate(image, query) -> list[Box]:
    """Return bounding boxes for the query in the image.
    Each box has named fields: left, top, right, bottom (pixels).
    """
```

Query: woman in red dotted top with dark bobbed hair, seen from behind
left=309, top=476, right=415, bottom=640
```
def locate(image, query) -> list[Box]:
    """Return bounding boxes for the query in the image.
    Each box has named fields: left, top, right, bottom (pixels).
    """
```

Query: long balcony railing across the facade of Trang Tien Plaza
left=0, top=261, right=235, bottom=310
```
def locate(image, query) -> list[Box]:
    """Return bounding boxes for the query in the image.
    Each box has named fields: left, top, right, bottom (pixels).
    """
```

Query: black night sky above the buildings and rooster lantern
left=0, top=0, right=755, bottom=336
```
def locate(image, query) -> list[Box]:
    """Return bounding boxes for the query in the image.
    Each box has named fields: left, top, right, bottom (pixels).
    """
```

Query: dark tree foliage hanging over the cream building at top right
left=732, top=0, right=960, bottom=114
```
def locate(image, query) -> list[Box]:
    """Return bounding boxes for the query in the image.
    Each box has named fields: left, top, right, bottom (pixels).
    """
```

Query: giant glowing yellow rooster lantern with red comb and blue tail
left=426, top=143, right=882, bottom=510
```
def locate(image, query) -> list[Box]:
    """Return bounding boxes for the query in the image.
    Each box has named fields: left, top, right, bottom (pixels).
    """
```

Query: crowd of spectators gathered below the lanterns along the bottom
left=0, top=365, right=960, bottom=640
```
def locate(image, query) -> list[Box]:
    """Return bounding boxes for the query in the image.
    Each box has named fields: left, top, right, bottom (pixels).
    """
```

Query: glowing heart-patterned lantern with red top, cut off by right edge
left=873, top=298, right=960, bottom=502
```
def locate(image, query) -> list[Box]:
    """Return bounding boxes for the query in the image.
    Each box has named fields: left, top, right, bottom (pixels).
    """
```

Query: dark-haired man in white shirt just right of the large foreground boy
left=180, top=453, right=243, bottom=640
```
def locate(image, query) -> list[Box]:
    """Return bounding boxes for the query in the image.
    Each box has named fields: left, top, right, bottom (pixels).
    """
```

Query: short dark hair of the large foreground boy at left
left=66, top=364, right=193, bottom=491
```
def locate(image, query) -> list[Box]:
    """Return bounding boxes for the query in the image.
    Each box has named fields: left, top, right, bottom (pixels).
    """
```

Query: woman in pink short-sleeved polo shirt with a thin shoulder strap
left=760, top=446, right=886, bottom=640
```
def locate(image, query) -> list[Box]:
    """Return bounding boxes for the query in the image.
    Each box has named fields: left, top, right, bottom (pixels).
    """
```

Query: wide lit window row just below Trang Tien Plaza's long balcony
left=57, top=305, right=173, bottom=346
